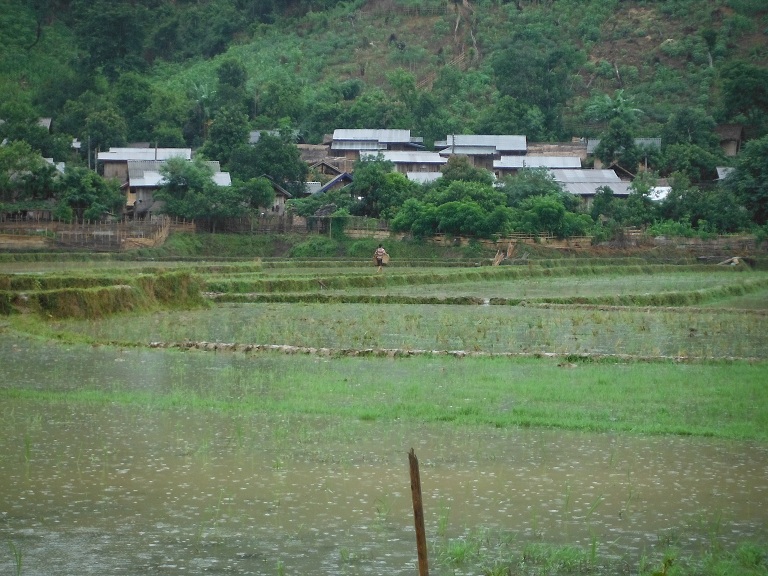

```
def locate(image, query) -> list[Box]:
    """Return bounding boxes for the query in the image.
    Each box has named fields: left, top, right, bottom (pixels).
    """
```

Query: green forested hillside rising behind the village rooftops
left=0, top=0, right=768, bottom=236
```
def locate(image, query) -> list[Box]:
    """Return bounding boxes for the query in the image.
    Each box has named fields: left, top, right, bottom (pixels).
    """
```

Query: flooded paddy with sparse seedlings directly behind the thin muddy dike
left=54, top=304, right=768, bottom=359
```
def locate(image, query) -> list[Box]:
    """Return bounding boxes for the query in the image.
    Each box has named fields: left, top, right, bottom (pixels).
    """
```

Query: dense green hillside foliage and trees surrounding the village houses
left=0, top=0, right=768, bottom=235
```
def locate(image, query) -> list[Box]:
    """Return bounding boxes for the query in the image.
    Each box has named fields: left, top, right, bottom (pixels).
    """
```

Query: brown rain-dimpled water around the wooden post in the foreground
left=0, top=340, right=768, bottom=575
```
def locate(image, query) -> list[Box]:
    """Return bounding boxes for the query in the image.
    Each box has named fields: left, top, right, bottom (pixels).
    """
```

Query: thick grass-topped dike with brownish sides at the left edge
left=0, top=272, right=206, bottom=318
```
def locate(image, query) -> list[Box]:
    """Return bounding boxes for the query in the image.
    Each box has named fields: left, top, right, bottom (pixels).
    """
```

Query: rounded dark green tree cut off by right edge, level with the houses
left=724, top=136, right=768, bottom=226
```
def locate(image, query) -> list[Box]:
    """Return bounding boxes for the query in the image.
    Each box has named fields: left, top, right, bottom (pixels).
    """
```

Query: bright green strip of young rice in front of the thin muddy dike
left=0, top=346, right=768, bottom=442
